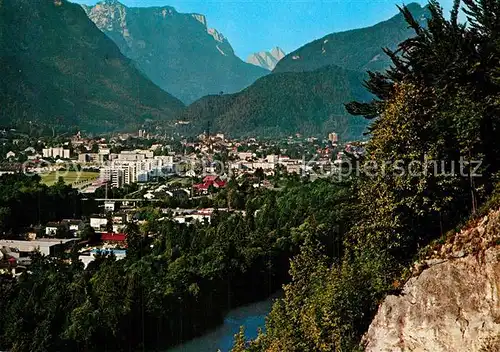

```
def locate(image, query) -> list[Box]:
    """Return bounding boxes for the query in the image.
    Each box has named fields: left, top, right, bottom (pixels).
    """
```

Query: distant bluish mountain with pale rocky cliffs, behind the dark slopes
left=83, top=0, right=269, bottom=103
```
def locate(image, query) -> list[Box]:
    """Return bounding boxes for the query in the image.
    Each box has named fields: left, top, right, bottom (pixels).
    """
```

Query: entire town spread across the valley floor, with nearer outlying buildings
left=0, top=129, right=365, bottom=274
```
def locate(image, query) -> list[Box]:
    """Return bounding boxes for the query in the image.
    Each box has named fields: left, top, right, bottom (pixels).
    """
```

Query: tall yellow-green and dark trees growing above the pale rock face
left=233, top=0, right=500, bottom=352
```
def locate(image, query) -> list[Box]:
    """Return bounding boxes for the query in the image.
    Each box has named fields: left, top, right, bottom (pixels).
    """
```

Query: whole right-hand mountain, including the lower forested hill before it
left=178, top=3, right=428, bottom=139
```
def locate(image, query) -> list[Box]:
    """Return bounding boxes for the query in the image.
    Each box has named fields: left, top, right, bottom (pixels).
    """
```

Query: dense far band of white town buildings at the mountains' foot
left=6, top=129, right=368, bottom=198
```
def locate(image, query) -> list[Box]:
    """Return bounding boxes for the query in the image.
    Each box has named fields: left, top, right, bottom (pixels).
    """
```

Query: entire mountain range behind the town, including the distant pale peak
left=0, top=0, right=428, bottom=139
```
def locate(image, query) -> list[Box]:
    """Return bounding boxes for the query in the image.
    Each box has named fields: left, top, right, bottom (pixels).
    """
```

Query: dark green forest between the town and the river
left=0, top=176, right=352, bottom=351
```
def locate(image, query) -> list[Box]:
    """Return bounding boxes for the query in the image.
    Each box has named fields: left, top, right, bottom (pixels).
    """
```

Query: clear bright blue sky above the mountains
left=73, top=0, right=453, bottom=60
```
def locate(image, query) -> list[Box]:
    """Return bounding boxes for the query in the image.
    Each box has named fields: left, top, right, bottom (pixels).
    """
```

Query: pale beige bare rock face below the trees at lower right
left=364, top=211, right=500, bottom=352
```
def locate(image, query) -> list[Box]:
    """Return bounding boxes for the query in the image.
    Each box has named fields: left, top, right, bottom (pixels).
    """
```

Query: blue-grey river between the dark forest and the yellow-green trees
left=167, top=296, right=276, bottom=352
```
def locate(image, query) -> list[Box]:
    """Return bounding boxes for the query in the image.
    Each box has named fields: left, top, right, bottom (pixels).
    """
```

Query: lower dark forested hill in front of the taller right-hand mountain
left=180, top=66, right=370, bottom=138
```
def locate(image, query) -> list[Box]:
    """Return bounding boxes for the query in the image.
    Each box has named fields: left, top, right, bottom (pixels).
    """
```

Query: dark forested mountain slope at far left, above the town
left=0, top=0, right=184, bottom=131
